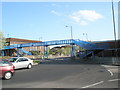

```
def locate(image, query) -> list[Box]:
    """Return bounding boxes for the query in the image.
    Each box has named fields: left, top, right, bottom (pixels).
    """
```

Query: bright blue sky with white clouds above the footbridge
left=1, top=2, right=118, bottom=41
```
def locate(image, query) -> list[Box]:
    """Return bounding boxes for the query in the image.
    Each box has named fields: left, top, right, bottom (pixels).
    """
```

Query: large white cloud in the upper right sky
left=69, top=10, right=103, bottom=25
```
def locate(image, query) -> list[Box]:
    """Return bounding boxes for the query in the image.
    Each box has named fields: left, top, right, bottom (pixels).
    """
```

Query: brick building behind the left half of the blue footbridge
left=5, top=38, right=44, bottom=56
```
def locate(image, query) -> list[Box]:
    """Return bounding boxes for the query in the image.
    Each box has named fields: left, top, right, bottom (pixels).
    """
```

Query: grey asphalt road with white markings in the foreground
left=2, top=59, right=120, bottom=88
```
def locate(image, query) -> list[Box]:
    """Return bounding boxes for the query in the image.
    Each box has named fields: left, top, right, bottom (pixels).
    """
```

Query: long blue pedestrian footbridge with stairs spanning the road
left=2, top=39, right=107, bottom=57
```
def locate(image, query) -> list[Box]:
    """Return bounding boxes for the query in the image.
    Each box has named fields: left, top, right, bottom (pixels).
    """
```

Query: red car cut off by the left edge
left=0, top=60, right=14, bottom=80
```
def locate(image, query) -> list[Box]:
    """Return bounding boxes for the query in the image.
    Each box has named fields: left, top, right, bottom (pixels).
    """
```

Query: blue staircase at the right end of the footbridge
left=74, top=39, right=108, bottom=58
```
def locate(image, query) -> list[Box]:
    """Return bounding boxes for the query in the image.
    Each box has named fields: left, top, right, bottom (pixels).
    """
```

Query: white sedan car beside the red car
left=8, top=57, right=33, bottom=69
